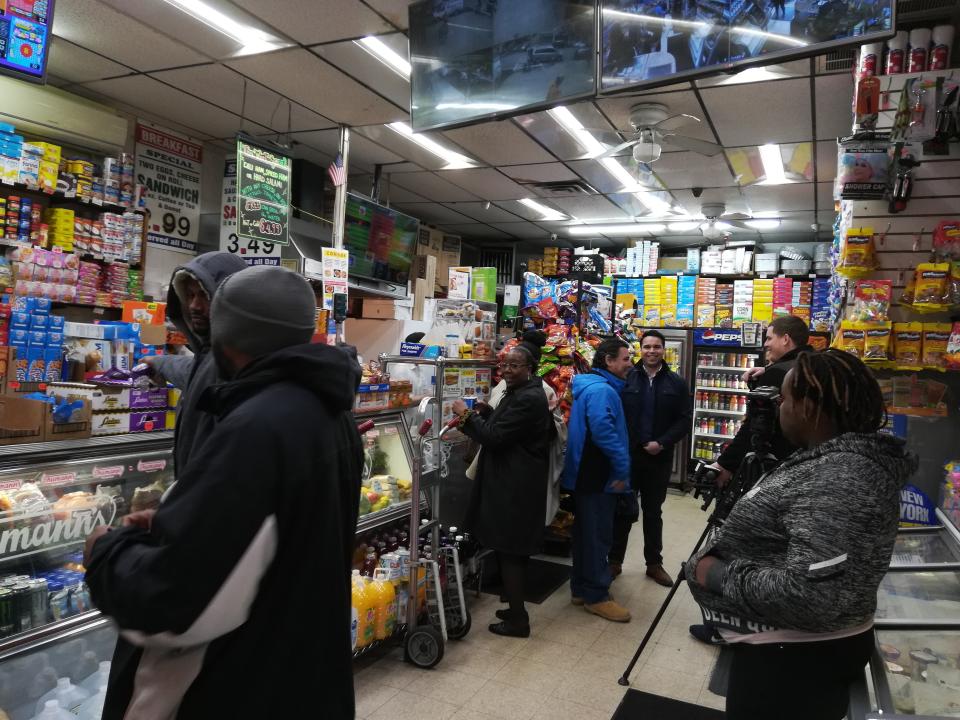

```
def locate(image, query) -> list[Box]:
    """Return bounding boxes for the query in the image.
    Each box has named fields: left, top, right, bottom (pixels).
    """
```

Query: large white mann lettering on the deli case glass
left=0, top=496, right=117, bottom=561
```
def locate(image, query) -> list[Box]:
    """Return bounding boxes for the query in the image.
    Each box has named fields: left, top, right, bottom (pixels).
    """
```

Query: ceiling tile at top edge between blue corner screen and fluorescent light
left=53, top=0, right=210, bottom=70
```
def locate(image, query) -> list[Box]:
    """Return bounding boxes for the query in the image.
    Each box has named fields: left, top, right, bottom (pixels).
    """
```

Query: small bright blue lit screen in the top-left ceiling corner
left=0, top=0, right=54, bottom=82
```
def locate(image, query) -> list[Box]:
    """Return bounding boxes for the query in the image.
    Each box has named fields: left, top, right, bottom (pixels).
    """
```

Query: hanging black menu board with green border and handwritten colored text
left=237, top=138, right=293, bottom=252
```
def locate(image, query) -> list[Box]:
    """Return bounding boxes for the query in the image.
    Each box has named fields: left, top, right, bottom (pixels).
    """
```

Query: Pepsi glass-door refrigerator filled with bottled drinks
left=690, top=328, right=763, bottom=462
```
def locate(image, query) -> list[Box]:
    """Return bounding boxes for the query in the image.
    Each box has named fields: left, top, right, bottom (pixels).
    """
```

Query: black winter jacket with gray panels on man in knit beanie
left=87, top=345, right=363, bottom=720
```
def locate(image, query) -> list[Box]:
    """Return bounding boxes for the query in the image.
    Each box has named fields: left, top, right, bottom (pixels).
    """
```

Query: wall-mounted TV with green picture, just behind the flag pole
left=343, top=193, right=420, bottom=285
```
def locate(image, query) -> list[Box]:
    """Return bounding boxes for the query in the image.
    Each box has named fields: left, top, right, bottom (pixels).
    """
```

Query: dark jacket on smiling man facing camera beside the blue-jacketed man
left=620, top=363, right=693, bottom=464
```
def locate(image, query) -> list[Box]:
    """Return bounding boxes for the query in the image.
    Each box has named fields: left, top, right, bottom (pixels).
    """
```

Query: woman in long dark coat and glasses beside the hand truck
left=453, top=341, right=555, bottom=637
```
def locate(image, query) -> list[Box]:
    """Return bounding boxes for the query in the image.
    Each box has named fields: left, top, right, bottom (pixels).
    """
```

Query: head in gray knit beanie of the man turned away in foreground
left=210, top=265, right=317, bottom=377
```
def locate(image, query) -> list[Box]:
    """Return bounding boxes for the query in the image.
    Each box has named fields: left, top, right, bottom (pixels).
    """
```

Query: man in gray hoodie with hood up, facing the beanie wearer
left=147, top=252, right=247, bottom=470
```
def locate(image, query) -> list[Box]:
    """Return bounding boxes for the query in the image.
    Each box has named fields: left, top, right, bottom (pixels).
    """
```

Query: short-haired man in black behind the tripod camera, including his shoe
left=690, top=315, right=812, bottom=645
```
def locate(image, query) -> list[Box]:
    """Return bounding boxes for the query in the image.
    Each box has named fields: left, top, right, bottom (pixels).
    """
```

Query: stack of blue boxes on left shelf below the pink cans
left=9, top=297, right=64, bottom=383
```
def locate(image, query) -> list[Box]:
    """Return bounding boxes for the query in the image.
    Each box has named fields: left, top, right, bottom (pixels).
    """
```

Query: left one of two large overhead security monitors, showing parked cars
left=410, top=0, right=597, bottom=130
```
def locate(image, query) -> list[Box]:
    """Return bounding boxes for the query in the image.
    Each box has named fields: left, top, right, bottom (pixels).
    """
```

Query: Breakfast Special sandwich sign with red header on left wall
left=136, top=121, right=203, bottom=255
